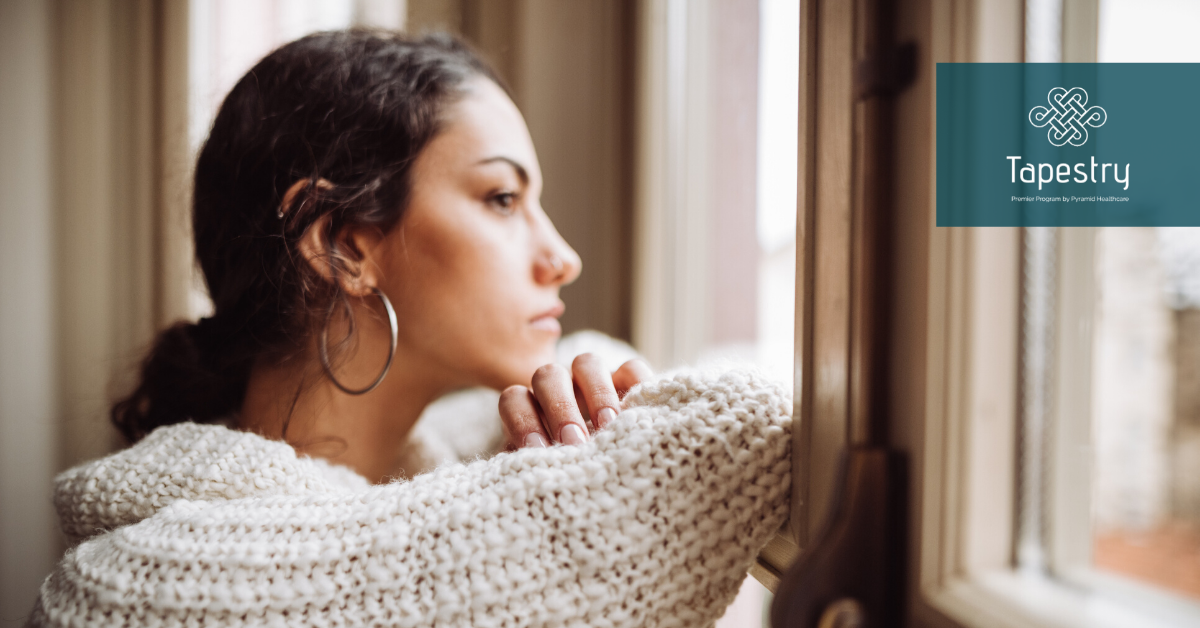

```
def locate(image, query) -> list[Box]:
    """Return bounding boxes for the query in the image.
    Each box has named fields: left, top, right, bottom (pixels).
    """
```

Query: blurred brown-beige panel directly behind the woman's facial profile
left=407, top=0, right=634, bottom=340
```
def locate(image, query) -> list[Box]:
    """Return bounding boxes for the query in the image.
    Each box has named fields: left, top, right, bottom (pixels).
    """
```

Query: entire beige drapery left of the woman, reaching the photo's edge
left=0, top=0, right=192, bottom=626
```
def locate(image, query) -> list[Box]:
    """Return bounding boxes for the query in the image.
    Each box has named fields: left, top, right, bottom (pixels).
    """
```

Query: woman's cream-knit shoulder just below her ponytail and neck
left=54, top=423, right=368, bottom=545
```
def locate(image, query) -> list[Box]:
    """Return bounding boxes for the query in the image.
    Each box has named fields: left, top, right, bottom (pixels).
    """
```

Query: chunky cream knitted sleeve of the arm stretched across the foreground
left=34, top=371, right=791, bottom=627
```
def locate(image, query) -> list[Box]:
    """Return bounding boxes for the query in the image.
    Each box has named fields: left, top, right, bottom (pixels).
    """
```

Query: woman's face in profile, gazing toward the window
left=377, top=78, right=581, bottom=389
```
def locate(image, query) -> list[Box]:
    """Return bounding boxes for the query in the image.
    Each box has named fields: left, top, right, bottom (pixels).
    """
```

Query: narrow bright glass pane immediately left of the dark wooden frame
left=700, top=0, right=800, bottom=382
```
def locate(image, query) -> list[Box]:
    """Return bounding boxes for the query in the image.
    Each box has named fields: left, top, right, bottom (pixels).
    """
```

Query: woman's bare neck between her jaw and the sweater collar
left=238, top=345, right=455, bottom=484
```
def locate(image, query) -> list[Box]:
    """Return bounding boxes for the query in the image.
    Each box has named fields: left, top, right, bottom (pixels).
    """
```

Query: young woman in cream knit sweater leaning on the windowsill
left=31, top=31, right=791, bottom=626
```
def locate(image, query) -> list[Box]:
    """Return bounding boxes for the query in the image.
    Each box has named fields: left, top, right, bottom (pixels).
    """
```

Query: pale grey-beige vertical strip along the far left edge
left=0, top=0, right=59, bottom=626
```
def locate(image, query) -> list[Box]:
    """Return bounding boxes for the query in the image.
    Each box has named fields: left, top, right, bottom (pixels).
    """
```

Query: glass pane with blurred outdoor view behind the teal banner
left=1092, top=0, right=1200, bottom=599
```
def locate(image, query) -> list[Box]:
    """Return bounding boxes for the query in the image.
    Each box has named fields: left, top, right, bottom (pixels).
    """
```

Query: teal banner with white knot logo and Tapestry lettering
left=937, top=64, right=1200, bottom=227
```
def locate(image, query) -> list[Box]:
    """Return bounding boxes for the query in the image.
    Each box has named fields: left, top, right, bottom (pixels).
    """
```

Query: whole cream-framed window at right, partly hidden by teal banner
left=912, top=0, right=1200, bottom=627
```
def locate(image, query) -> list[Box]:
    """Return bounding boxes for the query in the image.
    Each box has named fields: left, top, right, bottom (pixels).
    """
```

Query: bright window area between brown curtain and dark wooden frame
left=634, top=0, right=799, bottom=628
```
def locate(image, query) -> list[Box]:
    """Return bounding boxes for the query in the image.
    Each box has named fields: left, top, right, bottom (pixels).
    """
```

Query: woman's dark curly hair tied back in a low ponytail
left=112, top=29, right=503, bottom=442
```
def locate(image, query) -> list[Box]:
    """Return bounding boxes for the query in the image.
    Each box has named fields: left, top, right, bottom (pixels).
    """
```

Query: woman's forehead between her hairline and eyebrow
left=421, top=78, right=540, bottom=179
